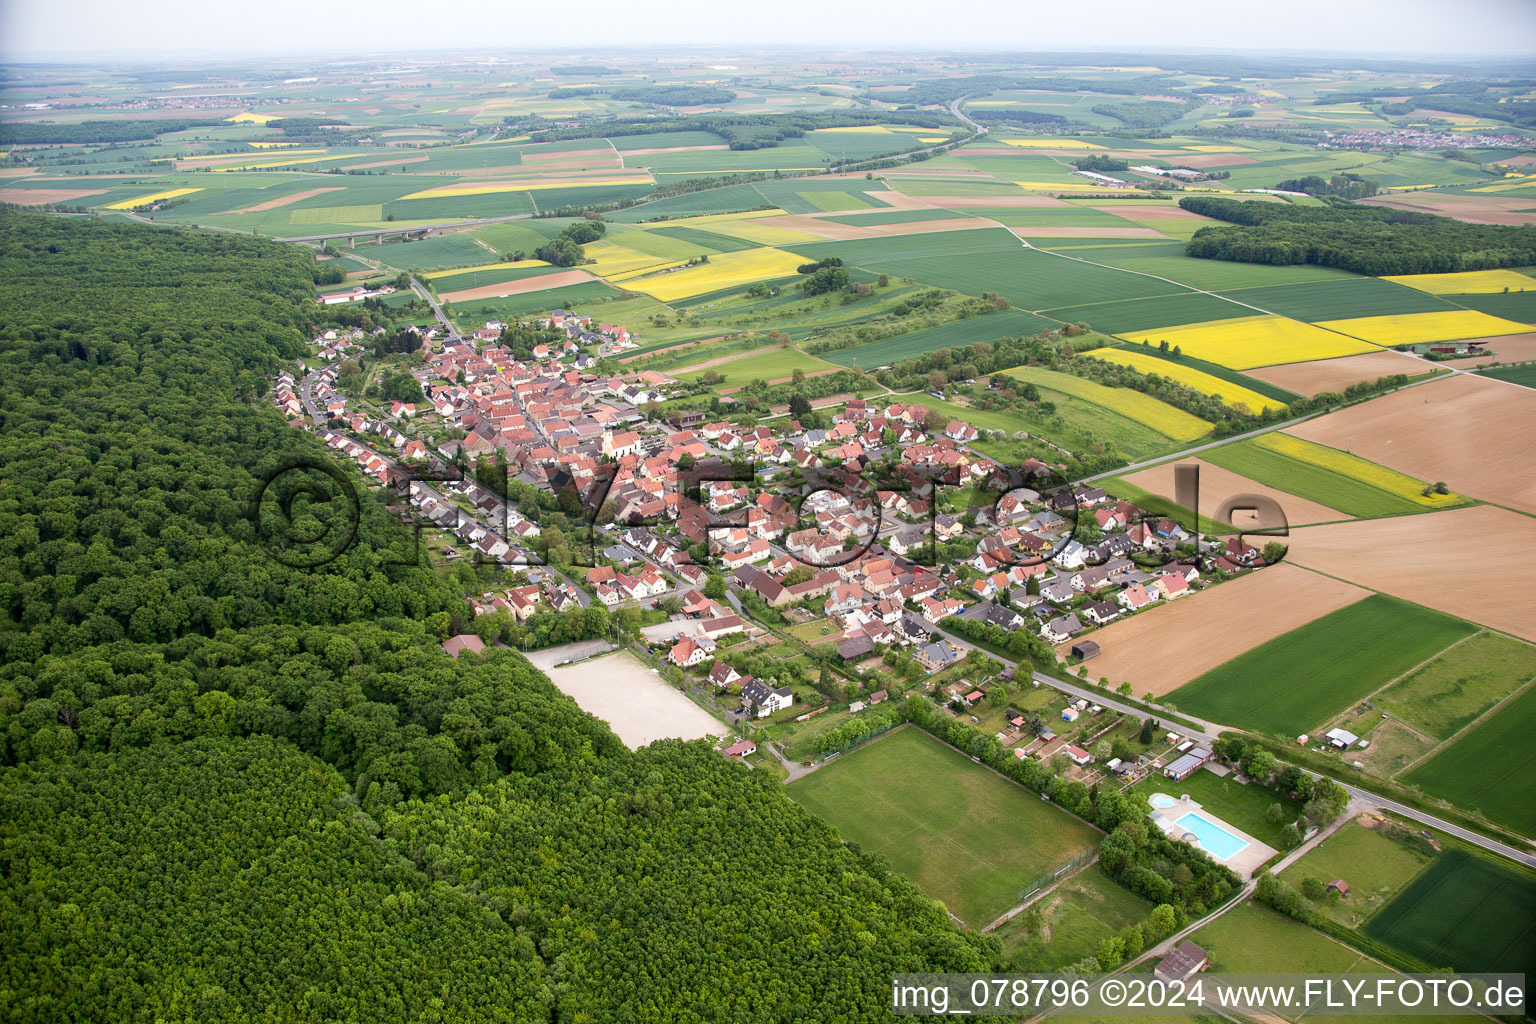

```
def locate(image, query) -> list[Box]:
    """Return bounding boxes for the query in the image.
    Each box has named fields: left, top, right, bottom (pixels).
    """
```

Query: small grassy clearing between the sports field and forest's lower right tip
left=994, top=866, right=1152, bottom=970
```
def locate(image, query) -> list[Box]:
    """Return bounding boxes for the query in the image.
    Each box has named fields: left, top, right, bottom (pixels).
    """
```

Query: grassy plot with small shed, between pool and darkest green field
left=1279, top=821, right=1435, bottom=927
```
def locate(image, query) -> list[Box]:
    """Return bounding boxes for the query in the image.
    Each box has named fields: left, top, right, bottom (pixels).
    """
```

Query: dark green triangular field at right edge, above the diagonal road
left=1401, top=675, right=1536, bottom=835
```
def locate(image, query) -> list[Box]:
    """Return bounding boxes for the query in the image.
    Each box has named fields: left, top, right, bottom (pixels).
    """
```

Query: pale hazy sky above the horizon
left=0, top=0, right=1536, bottom=60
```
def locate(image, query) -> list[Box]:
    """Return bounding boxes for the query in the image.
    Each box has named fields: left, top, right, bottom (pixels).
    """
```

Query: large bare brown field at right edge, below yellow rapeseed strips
left=1287, top=373, right=1536, bottom=512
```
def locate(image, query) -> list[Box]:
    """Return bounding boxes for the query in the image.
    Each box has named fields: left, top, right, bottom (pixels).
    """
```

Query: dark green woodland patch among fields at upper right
left=1178, top=195, right=1536, bottom=276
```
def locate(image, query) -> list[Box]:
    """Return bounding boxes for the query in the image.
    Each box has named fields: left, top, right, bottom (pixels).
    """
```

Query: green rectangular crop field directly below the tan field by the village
left=1169, top=594, right=1480, bottom=739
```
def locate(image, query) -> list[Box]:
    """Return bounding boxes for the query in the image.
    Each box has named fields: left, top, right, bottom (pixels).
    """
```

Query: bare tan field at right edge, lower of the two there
left=1284, top=505, right=1536, bottom=641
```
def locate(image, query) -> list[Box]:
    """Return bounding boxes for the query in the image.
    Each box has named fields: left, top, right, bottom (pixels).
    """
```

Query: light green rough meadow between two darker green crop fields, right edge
left=1376, top=633, right=1536, bottom=740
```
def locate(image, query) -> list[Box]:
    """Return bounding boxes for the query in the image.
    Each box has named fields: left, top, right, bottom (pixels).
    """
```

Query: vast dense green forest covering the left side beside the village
left=0, top=213, right=1000, bottom=1022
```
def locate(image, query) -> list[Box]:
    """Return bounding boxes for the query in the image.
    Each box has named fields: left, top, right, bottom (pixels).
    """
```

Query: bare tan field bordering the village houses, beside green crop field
left=1057, top=561, right=1370, bottom=697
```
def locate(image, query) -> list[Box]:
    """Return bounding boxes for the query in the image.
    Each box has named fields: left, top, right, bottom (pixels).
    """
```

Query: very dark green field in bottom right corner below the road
left=1363, top=849, right=1536, bottom=972
